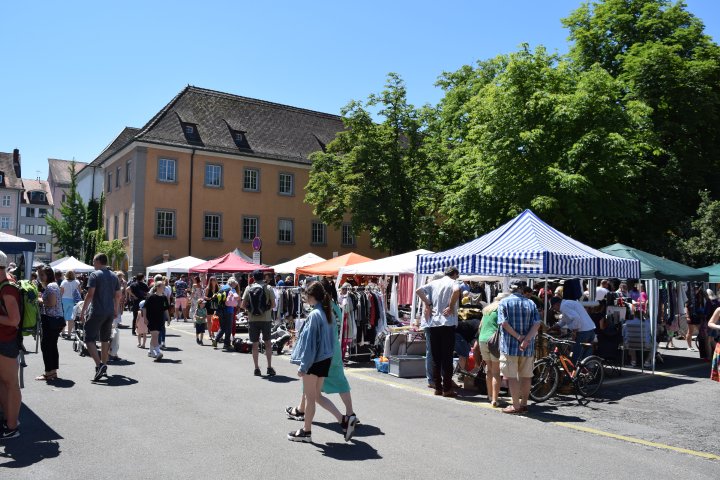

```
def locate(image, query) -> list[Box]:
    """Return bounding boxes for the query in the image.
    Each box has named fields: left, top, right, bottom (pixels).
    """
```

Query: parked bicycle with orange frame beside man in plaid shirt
left=530, top=333, right=605, bottom=403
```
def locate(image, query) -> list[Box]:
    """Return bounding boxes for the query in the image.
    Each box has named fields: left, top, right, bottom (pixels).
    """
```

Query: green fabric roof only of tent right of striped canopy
left=600, top=243, right=708, bottom=282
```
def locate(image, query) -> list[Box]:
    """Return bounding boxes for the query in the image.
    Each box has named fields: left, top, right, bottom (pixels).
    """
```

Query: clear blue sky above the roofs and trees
left=0, top=0, right=720, bottom=178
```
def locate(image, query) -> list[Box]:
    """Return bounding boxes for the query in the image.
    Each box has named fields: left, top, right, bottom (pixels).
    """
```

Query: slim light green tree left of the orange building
left=46, top=162, right=86, bottom=258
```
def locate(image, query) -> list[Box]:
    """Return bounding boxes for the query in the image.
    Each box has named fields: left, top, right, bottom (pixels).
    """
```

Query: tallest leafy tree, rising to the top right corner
left=563, top=0, right=720, bottom=255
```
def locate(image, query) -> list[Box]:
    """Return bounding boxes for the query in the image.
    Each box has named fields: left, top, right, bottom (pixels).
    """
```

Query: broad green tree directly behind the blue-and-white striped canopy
left=440, top=45, right=653, bottom=247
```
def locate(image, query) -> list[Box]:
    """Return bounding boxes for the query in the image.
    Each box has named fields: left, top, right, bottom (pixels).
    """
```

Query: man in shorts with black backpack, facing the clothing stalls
left=242, top=270, right=276, bottom=377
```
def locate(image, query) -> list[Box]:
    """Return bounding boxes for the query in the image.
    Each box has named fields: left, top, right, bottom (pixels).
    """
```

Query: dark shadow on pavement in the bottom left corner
left=0, top=404, right=63, bottom=466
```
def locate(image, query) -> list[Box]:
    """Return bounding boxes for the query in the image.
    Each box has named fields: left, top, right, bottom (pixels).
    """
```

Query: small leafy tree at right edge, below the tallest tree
left=680, top=190, right=720, bottom=268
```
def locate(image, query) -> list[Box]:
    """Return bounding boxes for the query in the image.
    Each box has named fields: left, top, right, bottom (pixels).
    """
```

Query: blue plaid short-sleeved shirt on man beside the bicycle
left=498, top=294, right=540, bottom=357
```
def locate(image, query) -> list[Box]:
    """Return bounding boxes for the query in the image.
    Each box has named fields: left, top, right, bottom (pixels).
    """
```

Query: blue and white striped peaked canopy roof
left=417, top=210, right=640, bottom=278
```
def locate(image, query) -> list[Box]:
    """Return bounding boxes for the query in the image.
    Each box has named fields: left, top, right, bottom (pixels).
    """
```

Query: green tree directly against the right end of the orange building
left=305, top=73, right=427, bottom=253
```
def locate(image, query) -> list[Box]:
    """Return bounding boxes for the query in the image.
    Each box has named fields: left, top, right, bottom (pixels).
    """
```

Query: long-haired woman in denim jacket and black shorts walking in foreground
left=288, top=282, right=335, bottom=443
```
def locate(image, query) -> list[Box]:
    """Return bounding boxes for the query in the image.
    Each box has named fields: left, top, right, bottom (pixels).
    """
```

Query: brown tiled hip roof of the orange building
left=91, top=86, right=344, bottom=165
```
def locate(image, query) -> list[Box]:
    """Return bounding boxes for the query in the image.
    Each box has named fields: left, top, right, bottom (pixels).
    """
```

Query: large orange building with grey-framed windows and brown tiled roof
left=88, top=86, right=383, bottom=273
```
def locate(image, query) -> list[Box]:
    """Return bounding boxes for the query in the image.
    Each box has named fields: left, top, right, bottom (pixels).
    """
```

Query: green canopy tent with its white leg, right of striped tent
left=600, top=243, right=709, bottom=373
